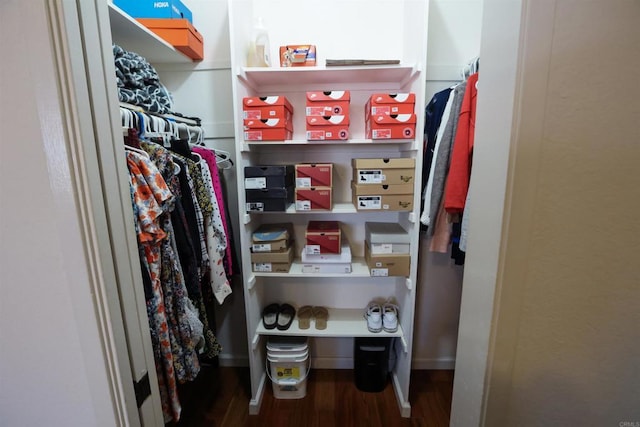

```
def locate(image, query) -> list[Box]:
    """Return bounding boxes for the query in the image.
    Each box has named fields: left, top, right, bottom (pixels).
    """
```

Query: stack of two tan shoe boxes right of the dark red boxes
left=351, top=158, right=415, bottom=211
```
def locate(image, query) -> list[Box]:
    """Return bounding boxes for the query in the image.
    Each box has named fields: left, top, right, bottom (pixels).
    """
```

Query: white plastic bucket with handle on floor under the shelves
left=266, top=337, right=311, bottom=399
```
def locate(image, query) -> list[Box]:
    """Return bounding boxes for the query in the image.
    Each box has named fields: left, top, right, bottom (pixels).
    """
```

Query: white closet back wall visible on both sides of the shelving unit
left=162, top=0, right=482, bottom=369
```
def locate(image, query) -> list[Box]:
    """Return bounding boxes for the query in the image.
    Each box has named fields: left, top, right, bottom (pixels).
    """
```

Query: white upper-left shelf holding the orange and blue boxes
left=109, top=2, right=193, bottom=64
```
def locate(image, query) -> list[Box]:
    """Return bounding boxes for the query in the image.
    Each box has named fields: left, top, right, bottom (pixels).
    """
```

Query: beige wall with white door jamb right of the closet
left=452, top=0, right=640, bottom=426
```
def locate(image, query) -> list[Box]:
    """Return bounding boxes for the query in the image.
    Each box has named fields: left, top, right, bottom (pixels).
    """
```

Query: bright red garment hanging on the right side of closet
left=444, top=73, right=478, bottom=217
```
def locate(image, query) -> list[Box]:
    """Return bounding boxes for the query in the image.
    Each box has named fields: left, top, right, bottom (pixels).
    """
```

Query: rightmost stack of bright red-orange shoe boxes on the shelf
left=364, top=93, right=416, bottom=139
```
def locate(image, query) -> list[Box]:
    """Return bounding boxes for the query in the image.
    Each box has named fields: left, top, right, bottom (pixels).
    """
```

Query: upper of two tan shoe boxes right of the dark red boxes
left=351, top=158, right=416, bottom=185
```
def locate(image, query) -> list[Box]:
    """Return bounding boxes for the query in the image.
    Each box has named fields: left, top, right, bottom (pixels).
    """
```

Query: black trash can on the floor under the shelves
left=353, top=337, right=392, bottom=392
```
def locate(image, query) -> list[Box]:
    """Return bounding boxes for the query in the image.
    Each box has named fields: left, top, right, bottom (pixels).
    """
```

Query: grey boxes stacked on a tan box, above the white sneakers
left=364, top=222, right=411, bottom=277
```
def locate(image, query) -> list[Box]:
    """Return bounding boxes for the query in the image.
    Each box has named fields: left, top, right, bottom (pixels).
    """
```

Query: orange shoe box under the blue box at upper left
left=137, top=18, right=204, bottom=61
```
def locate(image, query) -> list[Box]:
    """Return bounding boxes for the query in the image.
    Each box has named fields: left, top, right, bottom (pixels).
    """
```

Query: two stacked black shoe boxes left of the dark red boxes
left=244, top=165, right=294, bottom=212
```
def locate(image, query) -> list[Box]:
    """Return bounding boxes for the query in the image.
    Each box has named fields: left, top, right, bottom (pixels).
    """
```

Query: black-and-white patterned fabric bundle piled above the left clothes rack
left=113, top=45, right=173, bottom=113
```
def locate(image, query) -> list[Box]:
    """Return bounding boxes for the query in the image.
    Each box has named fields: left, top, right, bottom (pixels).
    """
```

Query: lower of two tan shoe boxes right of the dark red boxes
left=351, top=182, right=413, bottom=211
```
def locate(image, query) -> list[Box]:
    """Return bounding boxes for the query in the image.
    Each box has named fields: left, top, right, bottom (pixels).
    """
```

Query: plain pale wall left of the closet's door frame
left=0, top=0, right=121, bottom=426
